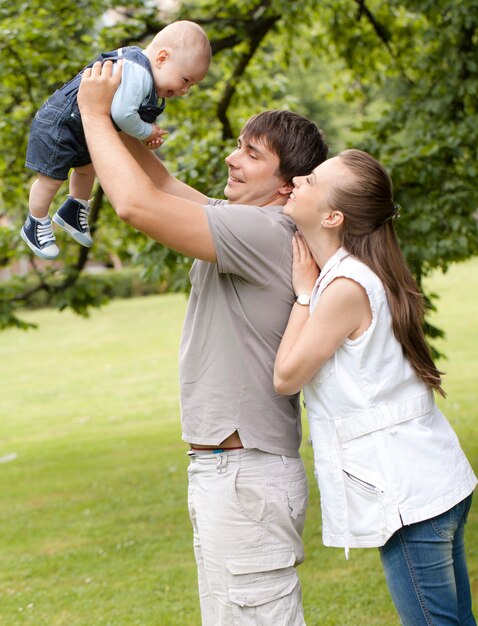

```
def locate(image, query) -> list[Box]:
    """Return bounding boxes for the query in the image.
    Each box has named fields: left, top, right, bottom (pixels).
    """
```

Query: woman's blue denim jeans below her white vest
left=379, top=495, right=476, bottom=626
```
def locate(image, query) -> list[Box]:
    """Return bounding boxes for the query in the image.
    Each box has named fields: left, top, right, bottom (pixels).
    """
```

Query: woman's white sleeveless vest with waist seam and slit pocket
left=304, top=248, right=477, bottom=555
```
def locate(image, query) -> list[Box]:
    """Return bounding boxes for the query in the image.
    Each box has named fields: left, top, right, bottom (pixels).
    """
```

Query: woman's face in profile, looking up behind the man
left=284, top=157, right=348, bottom=228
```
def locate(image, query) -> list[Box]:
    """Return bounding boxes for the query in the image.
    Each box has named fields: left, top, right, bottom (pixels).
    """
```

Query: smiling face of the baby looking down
left=153, top=50, right=208, bottom=98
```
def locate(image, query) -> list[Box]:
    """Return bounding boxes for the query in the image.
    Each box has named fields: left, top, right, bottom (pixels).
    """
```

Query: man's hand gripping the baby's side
left=78, top=61, right=123, bottom=117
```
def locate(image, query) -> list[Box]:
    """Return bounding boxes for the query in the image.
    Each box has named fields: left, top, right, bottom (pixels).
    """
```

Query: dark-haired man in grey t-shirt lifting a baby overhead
left=78, top=63, right=327, bottom=626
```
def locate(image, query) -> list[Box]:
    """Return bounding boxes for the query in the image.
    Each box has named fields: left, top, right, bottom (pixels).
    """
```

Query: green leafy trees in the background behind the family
left=0, top=0, right=478, bottom=333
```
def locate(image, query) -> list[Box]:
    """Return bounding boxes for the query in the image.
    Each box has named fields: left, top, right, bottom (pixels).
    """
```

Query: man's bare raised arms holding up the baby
left=78, top=61, right=216, bottom=261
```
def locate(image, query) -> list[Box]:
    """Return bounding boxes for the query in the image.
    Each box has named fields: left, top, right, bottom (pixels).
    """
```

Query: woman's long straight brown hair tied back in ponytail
left=329, top=150, right=445, bottom=396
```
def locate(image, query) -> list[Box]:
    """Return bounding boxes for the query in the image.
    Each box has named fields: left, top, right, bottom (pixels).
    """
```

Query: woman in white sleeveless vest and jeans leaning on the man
left=274, top=150, right=477, bottom=626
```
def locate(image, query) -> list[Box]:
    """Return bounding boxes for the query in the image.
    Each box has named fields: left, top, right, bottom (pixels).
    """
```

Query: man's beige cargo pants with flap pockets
left=188, top=450, right=308, bottom=626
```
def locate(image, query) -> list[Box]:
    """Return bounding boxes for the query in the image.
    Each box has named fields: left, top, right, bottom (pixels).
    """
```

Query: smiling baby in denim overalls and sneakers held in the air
left=20, top=20, right=211, bottom=259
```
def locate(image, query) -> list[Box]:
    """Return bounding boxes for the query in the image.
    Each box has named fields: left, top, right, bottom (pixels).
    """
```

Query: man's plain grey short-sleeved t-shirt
left=179, top=200, right=302, bottom=456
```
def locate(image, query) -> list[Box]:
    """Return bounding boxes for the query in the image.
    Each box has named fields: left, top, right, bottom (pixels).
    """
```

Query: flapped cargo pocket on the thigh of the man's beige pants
left=226, top=546, right=305, bottom=626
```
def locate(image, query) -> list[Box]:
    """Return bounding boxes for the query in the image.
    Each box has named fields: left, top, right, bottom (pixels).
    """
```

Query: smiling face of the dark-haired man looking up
left=224, top=135, right=292, bottom=206
